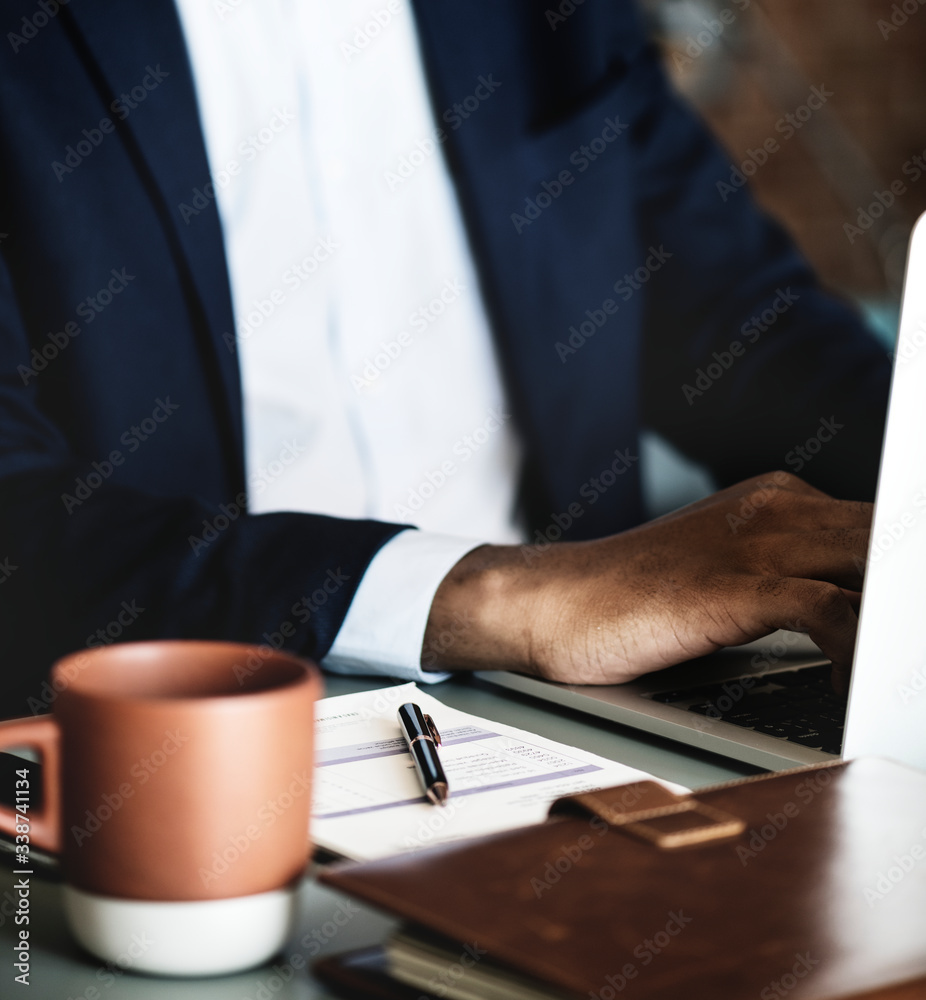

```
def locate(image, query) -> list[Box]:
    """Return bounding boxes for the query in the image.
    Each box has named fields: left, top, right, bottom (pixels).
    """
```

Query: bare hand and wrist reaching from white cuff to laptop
left=423, top=472, right=871, bottom=684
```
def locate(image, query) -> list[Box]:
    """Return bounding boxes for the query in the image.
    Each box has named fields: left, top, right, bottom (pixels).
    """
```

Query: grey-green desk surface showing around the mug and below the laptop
left=0, top=676, right=755, bottom=1000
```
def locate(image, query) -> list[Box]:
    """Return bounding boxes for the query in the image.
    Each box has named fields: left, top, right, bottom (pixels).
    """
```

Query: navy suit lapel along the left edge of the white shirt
left=61, top=0, right=244, bottom=489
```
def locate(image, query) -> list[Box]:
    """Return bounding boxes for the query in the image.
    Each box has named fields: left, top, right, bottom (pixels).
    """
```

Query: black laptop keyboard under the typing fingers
left=649, top=663, right=846, bottom=754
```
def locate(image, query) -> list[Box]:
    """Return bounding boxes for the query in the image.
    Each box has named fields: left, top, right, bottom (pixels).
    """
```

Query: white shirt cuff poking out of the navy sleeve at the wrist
left=321, top=530, right=484, bottom=683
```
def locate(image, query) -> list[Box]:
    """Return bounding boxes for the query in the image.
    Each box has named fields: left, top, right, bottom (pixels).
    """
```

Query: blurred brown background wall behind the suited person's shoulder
left=643, top=0, right=926, bottom=513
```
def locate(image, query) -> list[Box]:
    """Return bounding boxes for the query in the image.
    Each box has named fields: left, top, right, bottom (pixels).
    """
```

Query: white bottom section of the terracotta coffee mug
left=64, top=885, right=298, bottom=976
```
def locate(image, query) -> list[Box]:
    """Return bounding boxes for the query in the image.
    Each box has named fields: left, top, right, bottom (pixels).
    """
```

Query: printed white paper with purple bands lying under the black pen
left=312, top=684, right=687, bottom=860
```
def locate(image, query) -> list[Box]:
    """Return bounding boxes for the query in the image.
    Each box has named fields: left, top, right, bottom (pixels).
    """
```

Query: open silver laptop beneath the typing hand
left=477, top=214, right=926, bottom=770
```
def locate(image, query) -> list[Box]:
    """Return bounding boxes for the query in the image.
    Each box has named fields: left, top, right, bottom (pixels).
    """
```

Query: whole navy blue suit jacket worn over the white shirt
left=0, top=0, right=888, bottom=715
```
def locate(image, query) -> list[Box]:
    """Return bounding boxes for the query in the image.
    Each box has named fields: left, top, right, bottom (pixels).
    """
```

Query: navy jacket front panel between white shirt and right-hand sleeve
left=413, top=0, right=642, bottom=537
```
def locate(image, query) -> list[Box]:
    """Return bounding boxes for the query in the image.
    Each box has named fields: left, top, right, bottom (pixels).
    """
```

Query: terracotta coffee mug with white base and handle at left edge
left=0, top=641, right=321, bottom=975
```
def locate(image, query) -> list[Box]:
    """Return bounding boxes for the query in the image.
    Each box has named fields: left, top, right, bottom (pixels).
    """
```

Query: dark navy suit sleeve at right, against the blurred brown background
left=631, top=39, right=890, bottom=500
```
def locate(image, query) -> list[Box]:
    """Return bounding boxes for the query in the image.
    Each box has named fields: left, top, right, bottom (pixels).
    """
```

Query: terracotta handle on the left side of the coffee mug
left=0, top=715, right=61, bottom=854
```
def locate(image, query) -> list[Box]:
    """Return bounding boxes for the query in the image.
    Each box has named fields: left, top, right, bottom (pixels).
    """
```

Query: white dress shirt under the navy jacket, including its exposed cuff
left=170, top=0, right=522, bottom=680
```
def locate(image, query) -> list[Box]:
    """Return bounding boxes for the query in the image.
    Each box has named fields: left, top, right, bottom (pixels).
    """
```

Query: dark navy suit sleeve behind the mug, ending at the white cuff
left=0, top=252, right=414, bottom=716
